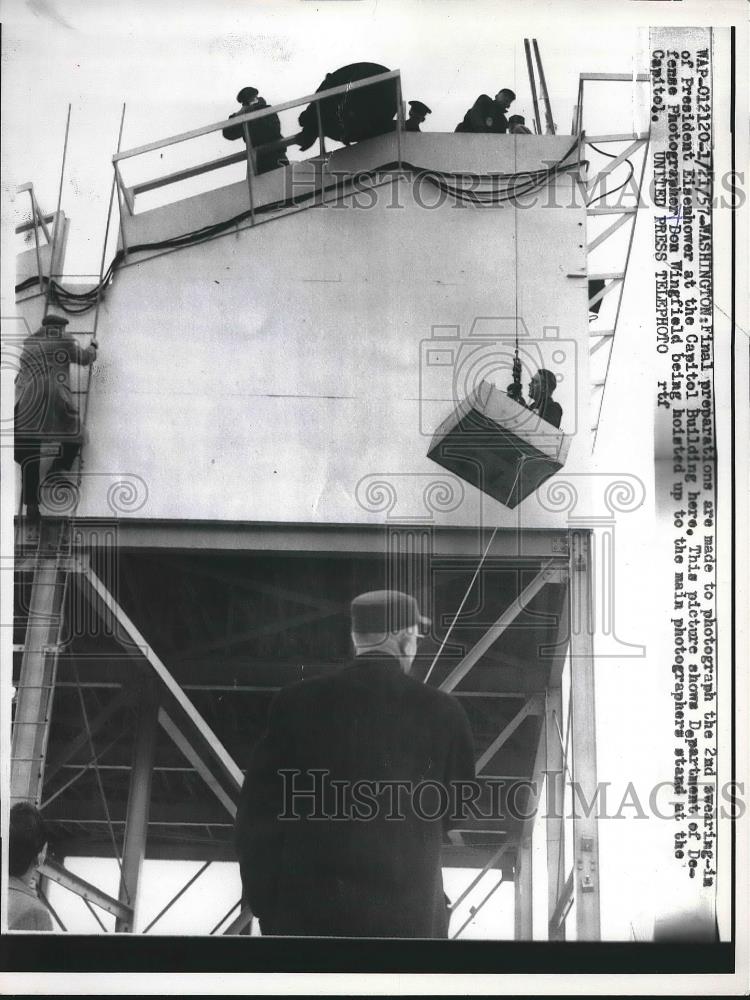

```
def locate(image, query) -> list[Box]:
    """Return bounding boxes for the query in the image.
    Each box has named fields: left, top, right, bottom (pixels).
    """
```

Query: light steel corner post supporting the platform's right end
left=570, top=529, right=601, bottom=941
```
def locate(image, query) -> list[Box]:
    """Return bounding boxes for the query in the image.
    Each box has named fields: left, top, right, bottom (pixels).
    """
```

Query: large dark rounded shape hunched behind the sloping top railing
left=298, top=63, right=396, bottom=150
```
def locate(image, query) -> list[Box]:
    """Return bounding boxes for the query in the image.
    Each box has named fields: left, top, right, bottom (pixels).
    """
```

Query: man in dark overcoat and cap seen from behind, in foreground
left=235, top=591, right=475, bottom=938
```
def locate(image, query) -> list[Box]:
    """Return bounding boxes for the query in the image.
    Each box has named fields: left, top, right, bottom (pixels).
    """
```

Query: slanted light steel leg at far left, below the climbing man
left=10, top=556, right=66, bottom=805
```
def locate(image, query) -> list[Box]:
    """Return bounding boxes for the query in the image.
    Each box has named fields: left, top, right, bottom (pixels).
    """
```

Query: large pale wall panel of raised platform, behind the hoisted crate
left=14, top=136, right=588, bottom=527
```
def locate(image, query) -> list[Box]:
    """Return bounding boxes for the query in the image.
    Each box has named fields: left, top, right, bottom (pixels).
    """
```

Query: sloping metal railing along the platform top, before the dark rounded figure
left=112, top=70, right=404, bottom=222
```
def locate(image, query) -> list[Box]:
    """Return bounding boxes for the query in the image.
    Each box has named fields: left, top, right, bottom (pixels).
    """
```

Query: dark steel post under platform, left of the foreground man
left=115, top=678, right=159, bottom=933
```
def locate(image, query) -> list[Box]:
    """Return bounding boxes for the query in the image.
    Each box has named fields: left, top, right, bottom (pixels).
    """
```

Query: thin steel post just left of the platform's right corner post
left=544, top=687, right=565, bottom=941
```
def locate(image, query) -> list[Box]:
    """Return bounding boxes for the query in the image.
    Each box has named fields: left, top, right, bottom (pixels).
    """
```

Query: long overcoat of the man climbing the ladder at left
left=15, top=327, right=96, bottom=441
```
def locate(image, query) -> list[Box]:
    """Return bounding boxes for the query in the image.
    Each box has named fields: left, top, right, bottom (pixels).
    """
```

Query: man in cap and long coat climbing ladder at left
left=14, top=314, right=99, bottom=520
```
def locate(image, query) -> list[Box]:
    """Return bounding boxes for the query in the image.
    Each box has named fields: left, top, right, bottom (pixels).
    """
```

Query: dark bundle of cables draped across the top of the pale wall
left=15, top=137, right=585, bottom=316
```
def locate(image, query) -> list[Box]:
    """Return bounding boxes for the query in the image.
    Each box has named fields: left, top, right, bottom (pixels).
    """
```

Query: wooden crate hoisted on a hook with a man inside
left=427, top=381, right=571, bottom=509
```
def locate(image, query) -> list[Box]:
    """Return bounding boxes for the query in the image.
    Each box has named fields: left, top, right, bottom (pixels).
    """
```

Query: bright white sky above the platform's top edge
left=2, top=0, right=645, bottom=274
